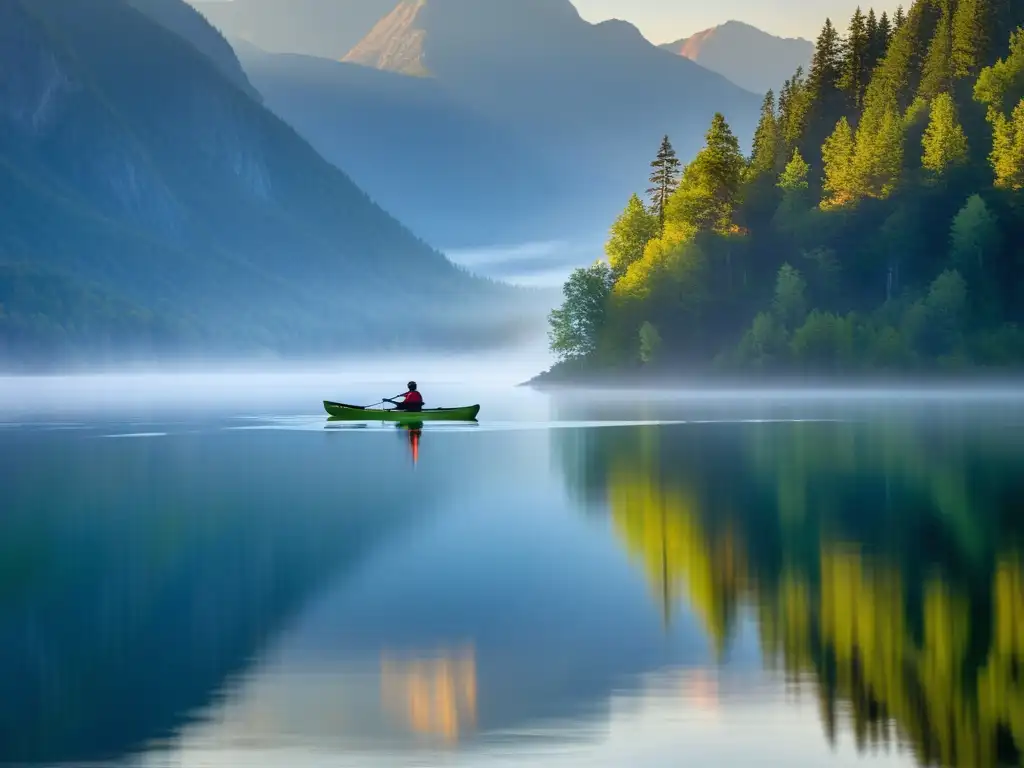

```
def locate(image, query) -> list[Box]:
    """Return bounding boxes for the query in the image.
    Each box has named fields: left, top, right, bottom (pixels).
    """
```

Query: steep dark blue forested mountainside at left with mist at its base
left=0, top=0, right=524, bottom=360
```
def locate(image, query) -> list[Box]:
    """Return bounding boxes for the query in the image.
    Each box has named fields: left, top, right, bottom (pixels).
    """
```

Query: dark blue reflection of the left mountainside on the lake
left=0, top=433, right=438, bottom=765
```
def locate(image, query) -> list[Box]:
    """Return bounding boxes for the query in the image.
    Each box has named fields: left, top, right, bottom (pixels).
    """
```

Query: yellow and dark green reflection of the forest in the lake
left=556, top=419, right=1024, bottom=768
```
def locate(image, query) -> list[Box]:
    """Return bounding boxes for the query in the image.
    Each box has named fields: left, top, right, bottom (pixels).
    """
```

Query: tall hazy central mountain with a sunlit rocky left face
left=335, top=0, right=760, bottom=240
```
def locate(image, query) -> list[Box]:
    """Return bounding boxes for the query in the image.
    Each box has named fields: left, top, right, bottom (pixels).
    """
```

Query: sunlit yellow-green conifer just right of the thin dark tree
left=668, top=113, right=746, bottom=232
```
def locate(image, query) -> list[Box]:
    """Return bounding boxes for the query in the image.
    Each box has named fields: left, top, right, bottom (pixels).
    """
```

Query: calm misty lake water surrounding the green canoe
left=0, top=375, right=1024, bottom=768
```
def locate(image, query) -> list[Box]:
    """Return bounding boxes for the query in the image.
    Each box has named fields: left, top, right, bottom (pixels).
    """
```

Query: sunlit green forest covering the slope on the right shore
left=539, top=0, right=1024, bottom=380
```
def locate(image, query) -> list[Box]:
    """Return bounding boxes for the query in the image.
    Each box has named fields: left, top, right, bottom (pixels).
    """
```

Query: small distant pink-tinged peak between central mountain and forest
left=662, top=22, right=814, bottom=93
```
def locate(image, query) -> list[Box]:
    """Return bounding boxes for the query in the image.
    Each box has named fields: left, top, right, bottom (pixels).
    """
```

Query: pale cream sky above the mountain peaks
left=572, top=0, right=910, bottom=43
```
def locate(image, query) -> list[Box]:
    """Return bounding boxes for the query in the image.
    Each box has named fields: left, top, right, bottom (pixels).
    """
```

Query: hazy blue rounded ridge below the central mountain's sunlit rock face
left=237, top=45, right=573, bottom=248
